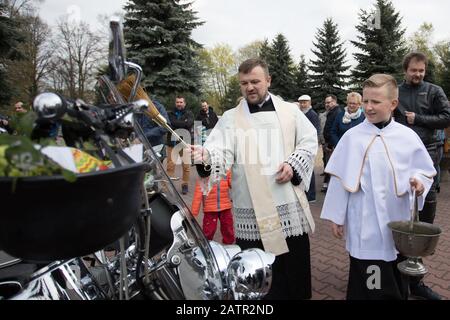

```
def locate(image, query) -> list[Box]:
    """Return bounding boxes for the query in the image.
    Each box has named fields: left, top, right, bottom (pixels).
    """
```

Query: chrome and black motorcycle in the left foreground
left=0, top=21, right=275, bottom=300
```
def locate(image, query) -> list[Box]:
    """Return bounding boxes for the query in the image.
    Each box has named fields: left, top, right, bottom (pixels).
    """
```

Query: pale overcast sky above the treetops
left=40, top=0, right=450, bottom=62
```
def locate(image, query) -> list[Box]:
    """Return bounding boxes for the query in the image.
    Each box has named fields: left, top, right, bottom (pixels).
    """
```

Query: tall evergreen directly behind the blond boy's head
left=352, top=0, right=406, bottom=88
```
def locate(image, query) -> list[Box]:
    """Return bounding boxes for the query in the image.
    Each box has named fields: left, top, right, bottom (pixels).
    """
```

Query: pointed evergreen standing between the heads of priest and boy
left=310, top=18, right=350, bottom=105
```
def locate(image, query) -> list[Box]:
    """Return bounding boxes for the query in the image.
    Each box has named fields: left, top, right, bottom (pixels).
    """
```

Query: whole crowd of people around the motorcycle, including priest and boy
left=0, top=52, right=450, bottom=300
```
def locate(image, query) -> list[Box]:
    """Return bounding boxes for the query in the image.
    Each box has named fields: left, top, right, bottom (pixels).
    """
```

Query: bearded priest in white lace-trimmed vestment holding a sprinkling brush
left=192, top=59, right=318, bottom=299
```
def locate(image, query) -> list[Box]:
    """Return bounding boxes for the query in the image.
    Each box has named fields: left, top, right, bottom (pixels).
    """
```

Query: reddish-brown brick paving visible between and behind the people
left=171, top=155, right=450, bottom=300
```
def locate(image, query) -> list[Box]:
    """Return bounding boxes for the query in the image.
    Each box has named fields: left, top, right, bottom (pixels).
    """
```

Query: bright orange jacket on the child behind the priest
left=192, top=171, right=231, bottom=216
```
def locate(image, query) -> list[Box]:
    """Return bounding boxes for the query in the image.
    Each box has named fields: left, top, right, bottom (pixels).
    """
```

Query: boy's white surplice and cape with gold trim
left=321, top=120, right=436, bottom=261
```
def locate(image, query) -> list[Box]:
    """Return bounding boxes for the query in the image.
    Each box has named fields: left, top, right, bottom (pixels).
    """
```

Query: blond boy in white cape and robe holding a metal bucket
left=321, top=74, right=436, bottom=300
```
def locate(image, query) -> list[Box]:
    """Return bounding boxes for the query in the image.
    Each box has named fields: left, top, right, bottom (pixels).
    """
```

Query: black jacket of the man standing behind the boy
left=394, top=81, right=450, bottom=147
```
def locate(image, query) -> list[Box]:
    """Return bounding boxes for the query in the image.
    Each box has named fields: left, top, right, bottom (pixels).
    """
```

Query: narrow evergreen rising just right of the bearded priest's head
left=267, top=33, right=297, bottom=100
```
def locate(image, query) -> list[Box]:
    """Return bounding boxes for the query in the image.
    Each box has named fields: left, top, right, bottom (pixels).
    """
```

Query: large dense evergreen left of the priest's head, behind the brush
left=124, top=0, right=203, bottom=97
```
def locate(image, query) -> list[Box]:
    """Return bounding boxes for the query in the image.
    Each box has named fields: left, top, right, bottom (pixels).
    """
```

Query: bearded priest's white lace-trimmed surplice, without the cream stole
left=204, top=96, right=318, bottom=240
